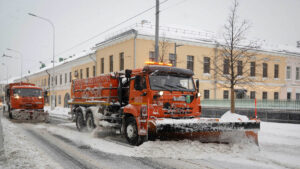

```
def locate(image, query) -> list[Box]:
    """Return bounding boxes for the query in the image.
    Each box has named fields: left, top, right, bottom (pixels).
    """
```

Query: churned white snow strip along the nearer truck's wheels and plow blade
left=35, top=119, right=300, bottom=168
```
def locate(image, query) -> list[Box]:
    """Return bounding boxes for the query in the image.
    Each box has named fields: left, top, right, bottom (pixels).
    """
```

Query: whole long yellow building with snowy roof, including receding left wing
left=15, top=25, right=300, bottom=107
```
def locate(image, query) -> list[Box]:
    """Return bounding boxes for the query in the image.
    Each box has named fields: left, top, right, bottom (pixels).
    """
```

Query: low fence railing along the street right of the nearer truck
left=201, top=99, right=300, bottom=112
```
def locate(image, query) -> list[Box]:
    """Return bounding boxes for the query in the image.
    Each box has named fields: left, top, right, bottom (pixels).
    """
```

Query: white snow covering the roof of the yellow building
left=104, top=23, right=300, bottom=56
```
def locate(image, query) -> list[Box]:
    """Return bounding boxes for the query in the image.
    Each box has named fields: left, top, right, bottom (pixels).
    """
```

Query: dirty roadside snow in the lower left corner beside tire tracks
left=0, top=118, right=61, bottom=169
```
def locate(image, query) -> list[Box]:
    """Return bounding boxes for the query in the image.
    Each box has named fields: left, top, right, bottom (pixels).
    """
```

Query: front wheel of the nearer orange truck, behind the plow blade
left=125, top=117, right=146, bottom=146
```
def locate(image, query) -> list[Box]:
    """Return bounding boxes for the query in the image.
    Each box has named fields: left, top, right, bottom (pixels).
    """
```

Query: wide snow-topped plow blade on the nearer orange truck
left=149, top=118, right=260, bottom=145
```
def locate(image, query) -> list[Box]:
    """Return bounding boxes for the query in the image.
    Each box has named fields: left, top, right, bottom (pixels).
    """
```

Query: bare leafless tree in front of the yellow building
left=212, top=0, right=259, bottom=113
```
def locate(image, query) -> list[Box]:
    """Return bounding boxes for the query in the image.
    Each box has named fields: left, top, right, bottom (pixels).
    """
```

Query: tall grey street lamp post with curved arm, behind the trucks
left=28, top=13, right=55, bottom=110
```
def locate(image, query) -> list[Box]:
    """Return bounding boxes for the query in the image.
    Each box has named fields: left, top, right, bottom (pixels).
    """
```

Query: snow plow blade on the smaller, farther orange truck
left=11, top=110, right=49, bottom=122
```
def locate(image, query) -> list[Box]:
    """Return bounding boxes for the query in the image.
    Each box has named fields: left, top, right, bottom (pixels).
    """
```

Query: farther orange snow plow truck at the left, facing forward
left=3, top=82, right=49, bottom=122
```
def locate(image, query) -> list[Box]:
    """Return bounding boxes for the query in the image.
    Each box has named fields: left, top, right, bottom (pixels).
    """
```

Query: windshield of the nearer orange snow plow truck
left=149, top=75, right=195, bottom=91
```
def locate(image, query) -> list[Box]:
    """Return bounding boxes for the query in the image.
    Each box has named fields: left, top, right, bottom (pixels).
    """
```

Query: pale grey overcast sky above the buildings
left=0, top=0, right=300, bottom=81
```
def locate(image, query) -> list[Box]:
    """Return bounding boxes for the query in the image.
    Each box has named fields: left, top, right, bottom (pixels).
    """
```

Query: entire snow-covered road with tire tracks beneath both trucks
left=0, top=111, right=300, bottom=169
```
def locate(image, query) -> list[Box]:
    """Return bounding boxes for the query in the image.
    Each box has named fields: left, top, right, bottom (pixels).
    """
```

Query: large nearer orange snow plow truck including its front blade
left=69, top=62, right=260, bottom=145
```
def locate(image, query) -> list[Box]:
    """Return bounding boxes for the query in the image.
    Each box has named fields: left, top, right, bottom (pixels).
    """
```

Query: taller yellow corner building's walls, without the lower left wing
left=96, top=25, right=286, bottom=100
